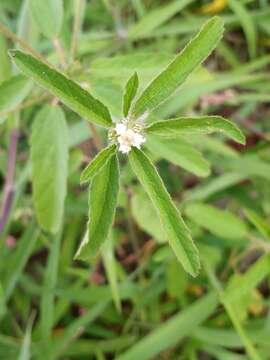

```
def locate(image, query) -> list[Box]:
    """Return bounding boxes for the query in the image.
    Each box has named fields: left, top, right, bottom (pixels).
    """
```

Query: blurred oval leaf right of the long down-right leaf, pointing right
left=185, top=203, right=247, bottom=239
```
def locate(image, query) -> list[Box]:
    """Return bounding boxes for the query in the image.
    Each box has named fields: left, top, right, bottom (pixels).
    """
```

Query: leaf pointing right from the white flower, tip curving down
left=145, top=116, right=245, bottom=144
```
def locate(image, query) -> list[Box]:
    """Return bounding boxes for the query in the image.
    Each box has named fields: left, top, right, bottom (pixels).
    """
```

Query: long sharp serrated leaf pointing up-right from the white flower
left=133, top=17, right=223, bottom=117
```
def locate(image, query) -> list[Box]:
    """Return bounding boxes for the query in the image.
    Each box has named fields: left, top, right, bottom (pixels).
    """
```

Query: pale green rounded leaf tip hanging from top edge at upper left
left=30, top=0, right=64, bottom=39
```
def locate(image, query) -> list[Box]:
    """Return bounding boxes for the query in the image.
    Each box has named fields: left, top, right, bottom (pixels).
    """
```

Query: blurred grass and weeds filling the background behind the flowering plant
left=0, top=0, right=270, bottom=360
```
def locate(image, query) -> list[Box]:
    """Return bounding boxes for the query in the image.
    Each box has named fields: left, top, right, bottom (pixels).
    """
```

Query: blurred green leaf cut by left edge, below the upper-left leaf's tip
left=0, top=75, right=33, bottom=118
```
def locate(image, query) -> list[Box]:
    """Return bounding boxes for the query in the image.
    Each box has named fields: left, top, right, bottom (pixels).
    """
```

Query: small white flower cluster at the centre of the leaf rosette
left=115, top=123, right=145, bottom=154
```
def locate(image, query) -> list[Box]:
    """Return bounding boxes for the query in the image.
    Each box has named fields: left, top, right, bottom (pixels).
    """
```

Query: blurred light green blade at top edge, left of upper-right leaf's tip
left=128, top=0, right=193, bottom=39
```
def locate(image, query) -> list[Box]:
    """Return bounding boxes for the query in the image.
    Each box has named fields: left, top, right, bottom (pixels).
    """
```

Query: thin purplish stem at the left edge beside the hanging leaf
left=0, top=128, right=19, bottom=236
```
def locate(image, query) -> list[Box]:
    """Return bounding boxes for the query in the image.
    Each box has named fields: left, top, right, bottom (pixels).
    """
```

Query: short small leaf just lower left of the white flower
left=80, top=144, right=116, bottom=184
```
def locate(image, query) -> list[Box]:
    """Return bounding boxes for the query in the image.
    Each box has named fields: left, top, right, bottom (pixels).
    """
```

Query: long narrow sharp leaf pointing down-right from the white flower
left=129, top=148, right=200, bottom=276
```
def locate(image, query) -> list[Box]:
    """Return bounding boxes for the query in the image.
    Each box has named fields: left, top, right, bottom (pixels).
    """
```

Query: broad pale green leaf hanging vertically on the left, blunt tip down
left=31, top=105, right=68, bottom=232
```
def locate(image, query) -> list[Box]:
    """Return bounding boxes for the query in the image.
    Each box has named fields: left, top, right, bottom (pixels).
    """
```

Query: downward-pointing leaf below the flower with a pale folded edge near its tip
left=76, top=154, right=119, bottom=260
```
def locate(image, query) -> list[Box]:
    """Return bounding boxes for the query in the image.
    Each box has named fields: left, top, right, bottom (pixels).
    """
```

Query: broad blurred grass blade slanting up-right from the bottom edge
left=116, top=293, right=218, bottom=360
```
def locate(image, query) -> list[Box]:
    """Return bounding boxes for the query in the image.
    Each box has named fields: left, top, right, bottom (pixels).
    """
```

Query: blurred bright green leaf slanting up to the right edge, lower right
left=222, top=255, right=270, bottom=302
